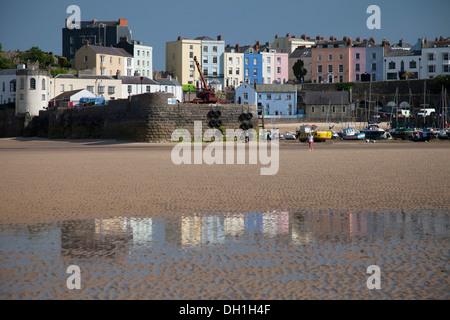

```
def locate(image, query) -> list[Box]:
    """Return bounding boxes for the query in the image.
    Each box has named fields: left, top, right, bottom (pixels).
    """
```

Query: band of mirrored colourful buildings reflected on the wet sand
left=49, top=211, right=449, bottom=260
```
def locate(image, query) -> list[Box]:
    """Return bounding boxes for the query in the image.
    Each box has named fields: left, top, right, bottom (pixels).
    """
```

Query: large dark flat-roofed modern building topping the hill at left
left=62, top=19, right=131, bottom=61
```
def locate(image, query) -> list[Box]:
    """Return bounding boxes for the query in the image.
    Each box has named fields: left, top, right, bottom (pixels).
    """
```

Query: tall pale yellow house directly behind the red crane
left=166, top=37, right=202, bottom=85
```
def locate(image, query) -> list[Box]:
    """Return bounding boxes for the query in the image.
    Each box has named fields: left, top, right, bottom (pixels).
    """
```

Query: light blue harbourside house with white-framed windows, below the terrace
left=235, top=83, right=298, bottom=118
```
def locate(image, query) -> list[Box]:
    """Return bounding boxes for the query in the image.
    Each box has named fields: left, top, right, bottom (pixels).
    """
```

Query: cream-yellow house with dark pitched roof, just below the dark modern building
left=74, top=41, right=134, bottom=76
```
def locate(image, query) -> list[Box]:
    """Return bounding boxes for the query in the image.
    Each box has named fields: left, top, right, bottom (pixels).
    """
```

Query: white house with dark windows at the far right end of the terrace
left=421, top=38, right=450, bottom=79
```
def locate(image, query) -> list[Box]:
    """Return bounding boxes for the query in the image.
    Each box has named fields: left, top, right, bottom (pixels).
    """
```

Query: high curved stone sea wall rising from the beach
left=0, top=93, right=258, bottom=142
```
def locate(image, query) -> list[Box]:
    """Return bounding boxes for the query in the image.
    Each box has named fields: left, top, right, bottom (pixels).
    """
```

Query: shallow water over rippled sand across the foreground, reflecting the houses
left=0, top=210, right=450, bottom=299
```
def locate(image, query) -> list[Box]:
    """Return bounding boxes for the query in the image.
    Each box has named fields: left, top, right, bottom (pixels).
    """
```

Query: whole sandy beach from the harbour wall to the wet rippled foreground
left=0, top=138, right=450, bottom=299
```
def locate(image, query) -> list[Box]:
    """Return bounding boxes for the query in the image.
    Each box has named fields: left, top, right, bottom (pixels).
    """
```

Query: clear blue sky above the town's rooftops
left=0, top=0, right=450, bottom=71
